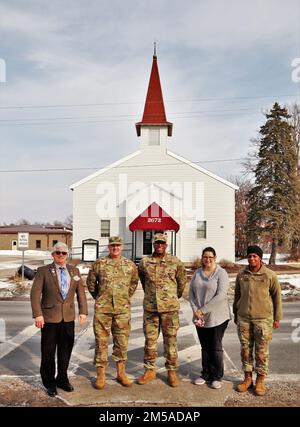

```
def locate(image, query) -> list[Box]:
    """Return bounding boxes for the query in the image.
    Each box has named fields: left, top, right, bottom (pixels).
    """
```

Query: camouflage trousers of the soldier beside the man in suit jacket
left=94, top=312, right=131, bottom=367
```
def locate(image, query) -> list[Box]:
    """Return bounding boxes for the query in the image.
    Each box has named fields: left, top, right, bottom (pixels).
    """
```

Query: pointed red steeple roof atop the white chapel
left=135, top=52, right=173, bottom=136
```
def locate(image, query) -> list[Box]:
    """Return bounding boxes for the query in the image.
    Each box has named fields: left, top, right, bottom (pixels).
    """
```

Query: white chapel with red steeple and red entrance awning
left=70, top=54, right=238, bottom=262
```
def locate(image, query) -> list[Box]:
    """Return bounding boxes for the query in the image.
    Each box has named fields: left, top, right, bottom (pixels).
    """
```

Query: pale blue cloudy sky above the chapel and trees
left=0, top=0, right=300, bottom=223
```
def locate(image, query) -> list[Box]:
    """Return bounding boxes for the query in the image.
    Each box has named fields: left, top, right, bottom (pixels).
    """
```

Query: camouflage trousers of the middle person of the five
left=143, top=311, right=179, bottom=370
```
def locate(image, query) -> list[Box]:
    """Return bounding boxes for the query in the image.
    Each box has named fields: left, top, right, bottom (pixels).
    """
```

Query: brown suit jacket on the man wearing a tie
left=30, top=263, right=88, bottom=323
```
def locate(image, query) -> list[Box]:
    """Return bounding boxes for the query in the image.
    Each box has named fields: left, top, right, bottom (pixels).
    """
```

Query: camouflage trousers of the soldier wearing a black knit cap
left=237, top=316, right=273, bottom=375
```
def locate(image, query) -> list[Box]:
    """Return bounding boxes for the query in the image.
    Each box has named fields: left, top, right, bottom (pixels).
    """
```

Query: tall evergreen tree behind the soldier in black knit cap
left=247, top=102, right=298, bottom=264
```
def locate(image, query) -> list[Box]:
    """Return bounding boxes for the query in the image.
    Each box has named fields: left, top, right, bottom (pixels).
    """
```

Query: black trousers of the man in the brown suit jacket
left=40, top=321, right=74, bottom=388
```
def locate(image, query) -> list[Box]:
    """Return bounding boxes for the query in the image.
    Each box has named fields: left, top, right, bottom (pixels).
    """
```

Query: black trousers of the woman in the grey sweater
left=196, top=320, right=229, bottom=381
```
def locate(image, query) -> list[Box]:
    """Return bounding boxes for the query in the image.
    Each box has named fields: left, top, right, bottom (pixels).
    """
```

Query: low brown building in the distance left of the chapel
left=0, top=225, right=73, bottom=251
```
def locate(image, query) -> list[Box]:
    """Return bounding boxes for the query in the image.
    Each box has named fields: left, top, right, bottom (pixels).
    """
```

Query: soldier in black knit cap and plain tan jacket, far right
left=233, top=245, right=282, bottom=396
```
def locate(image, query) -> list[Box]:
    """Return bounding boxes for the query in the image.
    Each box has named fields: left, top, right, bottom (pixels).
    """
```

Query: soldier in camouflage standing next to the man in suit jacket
left=87, top=236, right=138, bottom=389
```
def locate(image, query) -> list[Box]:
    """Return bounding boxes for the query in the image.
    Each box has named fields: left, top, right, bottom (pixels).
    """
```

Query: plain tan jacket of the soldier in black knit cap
left=233, top=265, right=282, bottom=320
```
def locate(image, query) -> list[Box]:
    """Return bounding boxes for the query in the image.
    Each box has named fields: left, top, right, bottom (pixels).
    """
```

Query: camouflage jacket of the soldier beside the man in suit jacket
left=86, top=256, right=139, bottom=314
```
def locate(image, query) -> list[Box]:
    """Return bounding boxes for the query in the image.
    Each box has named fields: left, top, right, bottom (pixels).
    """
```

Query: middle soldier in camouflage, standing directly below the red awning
left=138, top=233, right=187, bottom=387
